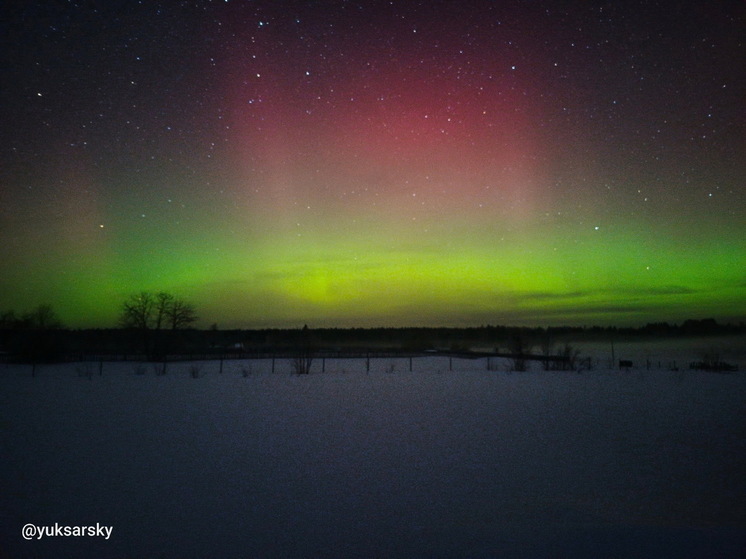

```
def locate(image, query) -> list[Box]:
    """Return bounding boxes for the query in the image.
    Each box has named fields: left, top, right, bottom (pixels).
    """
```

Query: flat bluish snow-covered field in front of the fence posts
left=0, top=347, right=746, bottom=559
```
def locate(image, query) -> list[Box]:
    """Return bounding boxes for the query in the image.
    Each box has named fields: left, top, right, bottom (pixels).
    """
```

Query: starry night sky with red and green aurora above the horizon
left=0, top=0, right=746, bottom=328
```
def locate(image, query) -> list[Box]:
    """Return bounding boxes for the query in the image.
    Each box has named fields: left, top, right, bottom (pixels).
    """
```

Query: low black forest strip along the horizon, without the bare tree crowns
left=0, top=316, right=746, bottom=362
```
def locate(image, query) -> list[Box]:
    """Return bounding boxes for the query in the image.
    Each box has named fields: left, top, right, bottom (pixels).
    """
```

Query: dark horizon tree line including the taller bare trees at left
left=0, top=306, right=746, bottom=364
